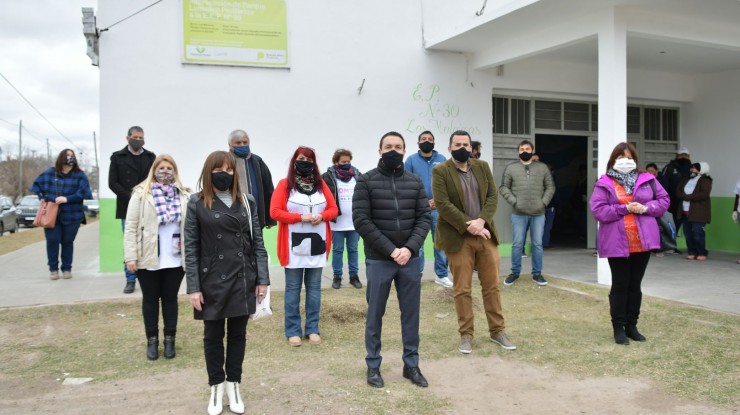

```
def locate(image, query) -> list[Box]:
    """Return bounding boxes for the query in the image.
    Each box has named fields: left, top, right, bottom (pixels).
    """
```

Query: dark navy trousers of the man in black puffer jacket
left=365, top=257, right=421, bottom=369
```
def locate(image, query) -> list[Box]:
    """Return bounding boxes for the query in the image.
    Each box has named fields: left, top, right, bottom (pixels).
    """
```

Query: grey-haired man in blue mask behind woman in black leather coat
left=229, top=130, right=277, bottom=228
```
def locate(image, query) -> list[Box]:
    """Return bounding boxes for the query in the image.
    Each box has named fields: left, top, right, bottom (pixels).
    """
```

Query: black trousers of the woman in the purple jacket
left=609, top=251, right=650, bottom=325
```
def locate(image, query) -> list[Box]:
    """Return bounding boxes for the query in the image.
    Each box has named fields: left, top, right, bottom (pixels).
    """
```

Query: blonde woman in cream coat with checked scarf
left=123, top=154, right=191, bottom=360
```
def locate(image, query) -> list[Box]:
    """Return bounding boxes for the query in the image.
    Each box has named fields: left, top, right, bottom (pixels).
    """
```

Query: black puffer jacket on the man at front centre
left=352, top=161, right=432, bottom=261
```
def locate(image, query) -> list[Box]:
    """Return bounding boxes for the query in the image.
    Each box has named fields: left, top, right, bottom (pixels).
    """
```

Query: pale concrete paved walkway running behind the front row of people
left=0, top=222, right=740, bottom=314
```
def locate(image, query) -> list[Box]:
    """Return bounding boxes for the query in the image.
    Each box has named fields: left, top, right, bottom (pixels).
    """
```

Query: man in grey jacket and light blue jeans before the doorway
left=499, top=140, right=555, bottom=285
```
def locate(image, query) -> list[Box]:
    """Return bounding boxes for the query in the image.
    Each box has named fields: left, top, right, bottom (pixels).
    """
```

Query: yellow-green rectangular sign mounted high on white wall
left=182, top=0, right=289, bottom=68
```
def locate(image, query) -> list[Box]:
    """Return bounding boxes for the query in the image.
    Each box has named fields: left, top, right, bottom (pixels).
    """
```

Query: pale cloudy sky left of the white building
left=0, top=0, right=100, bottom=167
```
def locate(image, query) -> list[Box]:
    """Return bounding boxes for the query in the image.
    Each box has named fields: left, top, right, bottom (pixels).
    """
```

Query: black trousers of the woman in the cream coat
left=136, top=267, right=185, bottom=337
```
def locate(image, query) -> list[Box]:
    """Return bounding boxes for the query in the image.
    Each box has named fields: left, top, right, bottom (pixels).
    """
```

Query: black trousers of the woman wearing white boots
left=203, top=316, right=249, bottom=386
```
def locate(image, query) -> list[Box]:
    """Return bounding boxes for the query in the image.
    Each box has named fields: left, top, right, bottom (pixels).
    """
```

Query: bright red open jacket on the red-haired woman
left=270, top=179, right=339, bottom=266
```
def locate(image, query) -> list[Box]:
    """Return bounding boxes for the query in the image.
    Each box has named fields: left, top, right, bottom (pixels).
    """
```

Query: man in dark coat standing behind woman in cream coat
left=108, top=126, right=156, bottom=294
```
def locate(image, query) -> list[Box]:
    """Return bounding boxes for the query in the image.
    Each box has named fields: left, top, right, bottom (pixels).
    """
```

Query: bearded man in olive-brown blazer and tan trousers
left=432, top=131, right=516, bottom=354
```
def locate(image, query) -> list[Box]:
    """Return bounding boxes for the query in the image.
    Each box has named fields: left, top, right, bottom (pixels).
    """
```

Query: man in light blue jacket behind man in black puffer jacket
left=404, top=131, right=452, bottom=288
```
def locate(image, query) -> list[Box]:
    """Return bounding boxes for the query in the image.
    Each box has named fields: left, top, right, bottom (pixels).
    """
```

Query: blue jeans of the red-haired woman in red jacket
left=285, top=268, right=323, bottom=337
